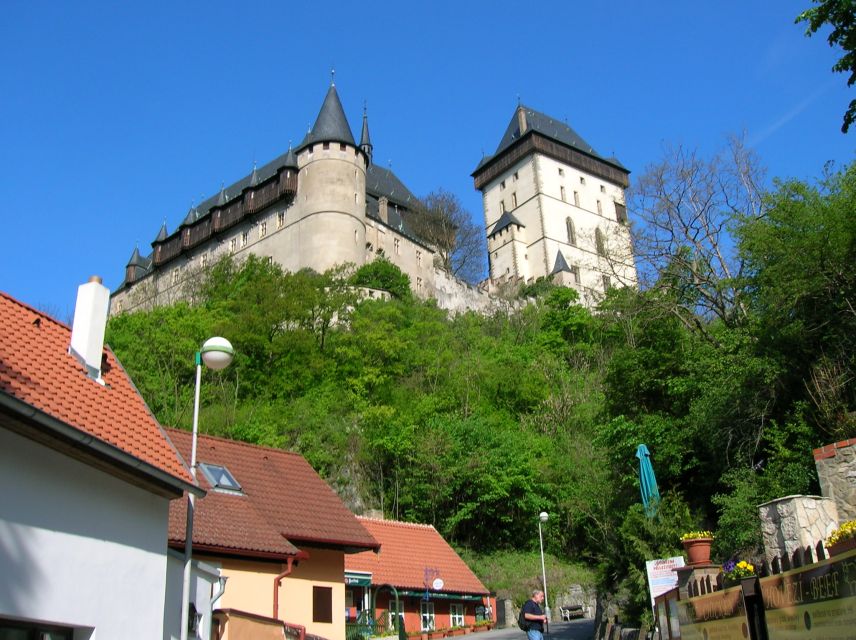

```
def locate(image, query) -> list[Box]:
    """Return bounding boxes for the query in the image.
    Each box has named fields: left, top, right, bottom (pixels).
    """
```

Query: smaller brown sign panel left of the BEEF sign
left=674, top=587, right=749, bottom=640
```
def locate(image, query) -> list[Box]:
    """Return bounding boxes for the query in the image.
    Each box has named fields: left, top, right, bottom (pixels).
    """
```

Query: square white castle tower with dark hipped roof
left=472, top=105, right=636, bottom=304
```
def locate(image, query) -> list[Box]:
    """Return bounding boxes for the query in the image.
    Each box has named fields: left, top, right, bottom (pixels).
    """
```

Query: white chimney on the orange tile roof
left=68, top=276, right=110, bottom=384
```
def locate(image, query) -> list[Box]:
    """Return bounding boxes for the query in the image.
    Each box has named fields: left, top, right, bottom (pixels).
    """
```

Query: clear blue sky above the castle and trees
left=0, top=0, right=856, bottom=320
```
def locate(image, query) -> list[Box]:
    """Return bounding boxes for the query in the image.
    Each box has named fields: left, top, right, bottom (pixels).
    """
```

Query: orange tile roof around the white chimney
left=0, top=292, right=191, bottom=483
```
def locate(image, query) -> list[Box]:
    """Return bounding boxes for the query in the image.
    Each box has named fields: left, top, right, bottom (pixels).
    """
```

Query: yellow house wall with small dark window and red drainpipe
left=204, top=549, right=345, bottom=640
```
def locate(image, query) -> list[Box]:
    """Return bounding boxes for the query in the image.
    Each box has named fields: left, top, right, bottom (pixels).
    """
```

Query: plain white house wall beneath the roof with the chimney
left=0, top=428, right=174, bottom=640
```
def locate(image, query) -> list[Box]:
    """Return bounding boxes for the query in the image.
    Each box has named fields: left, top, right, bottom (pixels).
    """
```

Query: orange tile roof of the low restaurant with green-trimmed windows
left=345, top=518, right=488, bottom=595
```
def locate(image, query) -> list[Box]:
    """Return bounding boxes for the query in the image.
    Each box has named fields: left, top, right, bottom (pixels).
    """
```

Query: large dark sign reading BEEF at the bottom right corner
left=761, top=550, right=856, bottom=640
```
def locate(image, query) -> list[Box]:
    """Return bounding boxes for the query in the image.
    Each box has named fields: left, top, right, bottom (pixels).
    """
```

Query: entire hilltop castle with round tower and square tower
left=111, top=84, right=636, bottom=313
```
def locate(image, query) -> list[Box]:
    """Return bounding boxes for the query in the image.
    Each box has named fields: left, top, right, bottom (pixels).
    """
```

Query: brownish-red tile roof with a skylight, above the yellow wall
left=167, top=429, right=378, bottom=556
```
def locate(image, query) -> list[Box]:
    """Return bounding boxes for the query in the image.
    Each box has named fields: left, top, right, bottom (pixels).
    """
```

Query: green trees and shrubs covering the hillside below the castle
left=108, top=158, right=856, bottom=618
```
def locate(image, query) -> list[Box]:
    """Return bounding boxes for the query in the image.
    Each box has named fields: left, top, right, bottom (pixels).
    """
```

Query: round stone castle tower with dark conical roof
left=285, top=84, right=368, bottom=273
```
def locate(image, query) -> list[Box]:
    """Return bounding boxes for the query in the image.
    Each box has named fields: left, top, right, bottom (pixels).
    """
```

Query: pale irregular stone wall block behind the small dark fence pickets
left=758, top=496, right=838, bottom=563
